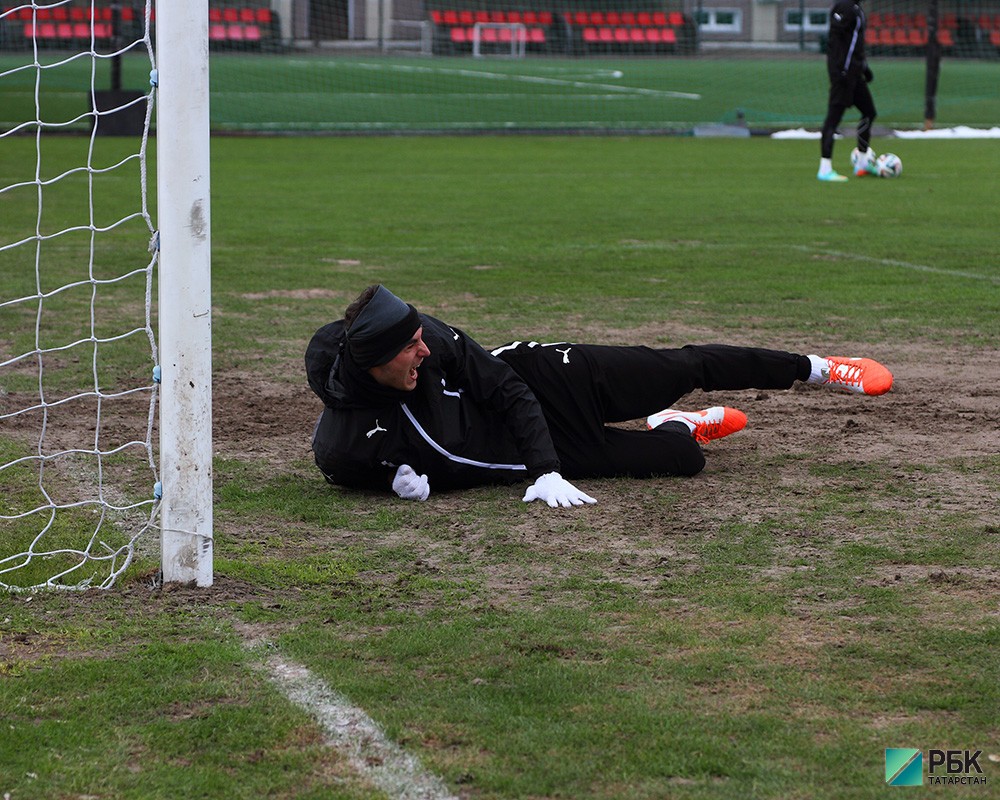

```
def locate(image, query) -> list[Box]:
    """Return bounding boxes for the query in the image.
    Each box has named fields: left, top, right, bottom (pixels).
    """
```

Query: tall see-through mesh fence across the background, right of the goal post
left=164, top=0, right=1000, bottom=134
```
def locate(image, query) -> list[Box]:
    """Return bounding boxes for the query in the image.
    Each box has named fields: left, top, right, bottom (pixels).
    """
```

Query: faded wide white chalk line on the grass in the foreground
left=260, top=642, right=457, bottom=800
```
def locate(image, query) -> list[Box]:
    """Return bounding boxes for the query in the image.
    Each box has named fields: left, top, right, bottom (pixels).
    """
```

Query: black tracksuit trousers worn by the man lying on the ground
left=495, top=343, right=810, bottom=478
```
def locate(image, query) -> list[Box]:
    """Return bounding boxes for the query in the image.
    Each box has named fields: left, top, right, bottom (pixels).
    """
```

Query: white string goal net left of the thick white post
left=0, top=2, right=158, bottom=590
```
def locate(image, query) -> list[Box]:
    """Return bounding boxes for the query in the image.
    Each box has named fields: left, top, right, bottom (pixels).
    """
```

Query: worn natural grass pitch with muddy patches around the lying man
left=0, top=137, right=1000, bottom=800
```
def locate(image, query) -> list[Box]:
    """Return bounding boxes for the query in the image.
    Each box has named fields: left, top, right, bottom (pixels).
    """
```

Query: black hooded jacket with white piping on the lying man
left=305, top=314, right=560, bottom=491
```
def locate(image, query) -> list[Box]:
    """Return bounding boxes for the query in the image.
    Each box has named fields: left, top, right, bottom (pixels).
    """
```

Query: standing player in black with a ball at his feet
left=816, top=0, right=878, bottom=183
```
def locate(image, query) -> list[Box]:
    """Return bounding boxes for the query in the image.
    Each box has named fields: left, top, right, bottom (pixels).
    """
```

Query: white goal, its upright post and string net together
left=0, top=0, right=213, bottom=591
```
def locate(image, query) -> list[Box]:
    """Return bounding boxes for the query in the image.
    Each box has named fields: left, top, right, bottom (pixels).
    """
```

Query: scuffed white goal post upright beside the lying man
left=156, top=0, right=214, bottom=586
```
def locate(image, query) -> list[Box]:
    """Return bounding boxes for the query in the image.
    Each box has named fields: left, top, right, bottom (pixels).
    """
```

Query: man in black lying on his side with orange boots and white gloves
left=305, top=285, right=892, bottom=507
